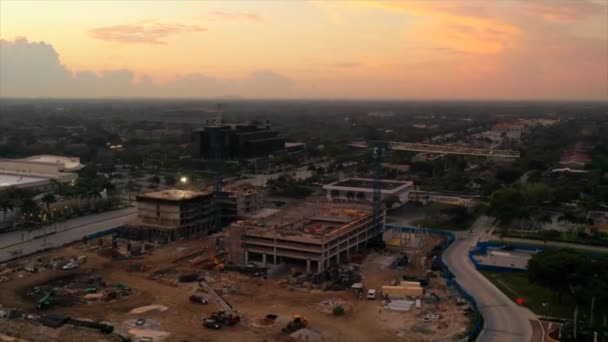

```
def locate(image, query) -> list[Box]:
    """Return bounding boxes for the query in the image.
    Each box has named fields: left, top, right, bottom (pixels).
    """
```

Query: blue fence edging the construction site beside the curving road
left=385, top=224, right=483, bottom=341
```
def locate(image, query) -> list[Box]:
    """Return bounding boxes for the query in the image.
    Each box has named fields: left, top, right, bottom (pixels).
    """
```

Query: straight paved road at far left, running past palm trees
left=0, top=208, right=137, bottom=262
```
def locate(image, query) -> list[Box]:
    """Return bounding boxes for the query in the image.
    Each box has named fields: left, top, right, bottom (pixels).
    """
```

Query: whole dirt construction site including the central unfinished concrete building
left=0, top=198, right=472, bottom=341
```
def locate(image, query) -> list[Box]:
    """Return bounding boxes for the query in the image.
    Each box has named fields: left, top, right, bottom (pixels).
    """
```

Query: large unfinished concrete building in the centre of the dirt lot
left=228, top=202, right=385, bottom=273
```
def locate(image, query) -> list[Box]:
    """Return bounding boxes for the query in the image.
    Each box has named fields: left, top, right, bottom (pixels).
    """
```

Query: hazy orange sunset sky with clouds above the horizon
left=0, top=0, right=608, bottom=100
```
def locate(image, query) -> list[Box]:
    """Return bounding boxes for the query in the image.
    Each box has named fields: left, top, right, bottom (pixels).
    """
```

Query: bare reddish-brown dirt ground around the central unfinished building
left=0, top=234, right=467, bottom=342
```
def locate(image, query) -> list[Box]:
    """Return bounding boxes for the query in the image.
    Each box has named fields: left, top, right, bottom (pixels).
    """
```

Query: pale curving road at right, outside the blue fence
left=443, top=219, right=536, bottom=342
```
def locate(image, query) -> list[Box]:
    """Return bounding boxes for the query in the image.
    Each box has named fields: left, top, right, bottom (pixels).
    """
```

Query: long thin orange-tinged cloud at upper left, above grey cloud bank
left=89, top=23, right=206, bottom=44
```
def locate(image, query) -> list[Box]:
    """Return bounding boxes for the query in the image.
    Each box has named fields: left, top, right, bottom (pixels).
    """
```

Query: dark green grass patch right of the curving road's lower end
left=481, top=271, right=574, bottom=318
